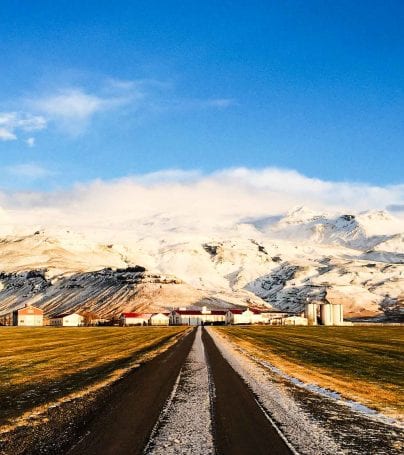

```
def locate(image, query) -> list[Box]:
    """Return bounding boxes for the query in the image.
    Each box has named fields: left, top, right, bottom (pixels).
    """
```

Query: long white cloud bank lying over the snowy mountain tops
left=0, top=168, right=404, bottom=236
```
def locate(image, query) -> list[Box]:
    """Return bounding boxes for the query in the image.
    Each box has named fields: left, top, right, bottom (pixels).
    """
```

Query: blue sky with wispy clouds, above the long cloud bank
left=0, top=0, right=404, bottom=191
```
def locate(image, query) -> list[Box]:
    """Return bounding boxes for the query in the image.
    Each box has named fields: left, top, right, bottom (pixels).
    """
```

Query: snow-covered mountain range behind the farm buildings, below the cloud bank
left=0, top=207, right=404, bottom=317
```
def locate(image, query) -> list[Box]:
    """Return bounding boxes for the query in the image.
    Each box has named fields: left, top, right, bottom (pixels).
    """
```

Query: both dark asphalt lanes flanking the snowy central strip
left=67, top=330, right=291, bottom=455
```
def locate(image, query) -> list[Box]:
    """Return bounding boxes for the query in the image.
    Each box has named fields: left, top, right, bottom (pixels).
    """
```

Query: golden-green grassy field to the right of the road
left=217, top=326, right=404, bottom=416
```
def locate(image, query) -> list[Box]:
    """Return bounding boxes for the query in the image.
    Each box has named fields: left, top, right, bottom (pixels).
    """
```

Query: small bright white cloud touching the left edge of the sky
left=0, top=111, right=46, bottom=141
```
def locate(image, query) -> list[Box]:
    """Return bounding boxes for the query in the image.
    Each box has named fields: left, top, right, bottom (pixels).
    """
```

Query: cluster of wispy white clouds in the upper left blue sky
left=0, top=73, right=237, bottom=142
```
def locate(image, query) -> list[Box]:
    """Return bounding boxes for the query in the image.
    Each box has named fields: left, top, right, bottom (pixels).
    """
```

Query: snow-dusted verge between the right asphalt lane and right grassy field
left=211, top=329, right=404, bottom=455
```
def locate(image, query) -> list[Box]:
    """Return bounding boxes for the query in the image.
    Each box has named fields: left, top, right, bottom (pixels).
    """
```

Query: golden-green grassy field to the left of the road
left=0, top=327, right=188, bottom=428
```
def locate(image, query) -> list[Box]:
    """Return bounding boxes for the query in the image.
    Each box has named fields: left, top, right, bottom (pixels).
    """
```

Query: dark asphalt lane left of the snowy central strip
left=67, top=331, right=195, bottom=455
